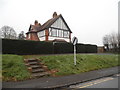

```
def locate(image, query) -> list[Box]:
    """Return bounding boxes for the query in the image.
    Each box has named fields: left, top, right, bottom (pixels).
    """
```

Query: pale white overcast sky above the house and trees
left=0, top=0, right=120, bottom=46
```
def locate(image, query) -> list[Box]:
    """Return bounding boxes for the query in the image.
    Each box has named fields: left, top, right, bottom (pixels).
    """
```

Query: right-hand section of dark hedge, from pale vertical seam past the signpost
left=54, top=43, right=97, bottom=54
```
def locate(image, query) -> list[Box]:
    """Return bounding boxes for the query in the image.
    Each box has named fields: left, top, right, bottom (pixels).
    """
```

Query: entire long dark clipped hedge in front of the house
left=2, top=39, right=97, bottom=55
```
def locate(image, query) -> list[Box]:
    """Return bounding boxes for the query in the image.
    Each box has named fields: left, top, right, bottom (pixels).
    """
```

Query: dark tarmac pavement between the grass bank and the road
left=2, top=66, right=120, bottom=88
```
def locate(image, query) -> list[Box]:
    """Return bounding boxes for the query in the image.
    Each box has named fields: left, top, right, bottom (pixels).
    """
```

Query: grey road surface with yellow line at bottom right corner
left=70, top=74, right=120, bottom=88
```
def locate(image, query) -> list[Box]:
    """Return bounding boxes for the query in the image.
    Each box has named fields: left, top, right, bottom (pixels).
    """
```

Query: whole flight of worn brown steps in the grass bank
left=24, top=59, right=49, bottom=78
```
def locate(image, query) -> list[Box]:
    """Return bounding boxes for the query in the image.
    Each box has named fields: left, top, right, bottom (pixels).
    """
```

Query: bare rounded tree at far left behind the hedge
left=0, top=26, right=17, bottom=39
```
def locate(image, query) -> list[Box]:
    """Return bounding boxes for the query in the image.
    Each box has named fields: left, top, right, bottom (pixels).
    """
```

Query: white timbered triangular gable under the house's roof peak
left=51, top=17, right=69, bottom=30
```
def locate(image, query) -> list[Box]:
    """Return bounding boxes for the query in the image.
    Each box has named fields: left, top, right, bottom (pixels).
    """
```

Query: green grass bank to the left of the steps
left=2, top=55, right=30, bottom=81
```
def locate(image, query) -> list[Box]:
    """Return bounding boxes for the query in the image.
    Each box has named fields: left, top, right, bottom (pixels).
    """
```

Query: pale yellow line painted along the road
left=77, top=77, right=114, bottom=88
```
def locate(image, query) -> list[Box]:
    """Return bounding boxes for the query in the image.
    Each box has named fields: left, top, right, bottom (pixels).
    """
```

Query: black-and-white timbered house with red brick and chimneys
left=26, top=12, right=72, bottom=42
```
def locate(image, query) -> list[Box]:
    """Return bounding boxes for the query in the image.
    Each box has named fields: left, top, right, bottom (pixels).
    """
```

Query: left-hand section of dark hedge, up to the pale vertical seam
left=2, top=39, right=53, bottom=55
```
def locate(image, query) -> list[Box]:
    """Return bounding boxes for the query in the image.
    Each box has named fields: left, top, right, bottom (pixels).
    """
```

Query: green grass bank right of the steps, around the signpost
left=25, top=54, right=118, bottom=76
